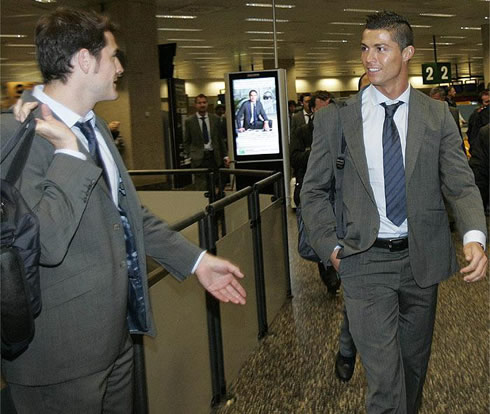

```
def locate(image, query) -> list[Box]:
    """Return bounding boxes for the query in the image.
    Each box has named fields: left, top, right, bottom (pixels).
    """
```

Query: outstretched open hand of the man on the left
left=196, top=253, right=247, bottom=305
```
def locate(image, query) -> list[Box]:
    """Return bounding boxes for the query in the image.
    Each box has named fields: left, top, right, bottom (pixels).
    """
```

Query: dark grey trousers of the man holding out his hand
left=9, top=335, right=133, bottom=414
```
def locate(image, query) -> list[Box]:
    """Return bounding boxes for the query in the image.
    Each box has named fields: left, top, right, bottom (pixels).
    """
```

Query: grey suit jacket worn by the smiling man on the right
left=301, top=88, right=486, bottom=287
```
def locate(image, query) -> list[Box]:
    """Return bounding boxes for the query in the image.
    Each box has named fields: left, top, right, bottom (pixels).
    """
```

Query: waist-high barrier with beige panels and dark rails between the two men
left=130, top=170, right=291, bottom=414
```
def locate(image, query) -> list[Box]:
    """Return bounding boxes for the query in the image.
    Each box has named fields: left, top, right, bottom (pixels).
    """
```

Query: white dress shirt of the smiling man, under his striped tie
left=361, top=85, right=485, bottom=246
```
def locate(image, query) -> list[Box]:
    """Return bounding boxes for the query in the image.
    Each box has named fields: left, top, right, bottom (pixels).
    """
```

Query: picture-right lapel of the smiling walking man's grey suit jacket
left=405, top=88, right=427, bottom=183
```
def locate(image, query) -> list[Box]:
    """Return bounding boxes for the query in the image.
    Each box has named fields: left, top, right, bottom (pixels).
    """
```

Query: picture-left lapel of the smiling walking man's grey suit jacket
left=339, top=93, right=376, bottom=203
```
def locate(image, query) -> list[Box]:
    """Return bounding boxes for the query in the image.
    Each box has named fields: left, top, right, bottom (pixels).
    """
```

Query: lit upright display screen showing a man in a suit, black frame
left=227, top=70, right=284, bottom=161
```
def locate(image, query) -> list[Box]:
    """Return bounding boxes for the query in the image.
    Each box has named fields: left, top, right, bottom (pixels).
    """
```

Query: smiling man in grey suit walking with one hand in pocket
left=301, top=12, right=487, bottom=414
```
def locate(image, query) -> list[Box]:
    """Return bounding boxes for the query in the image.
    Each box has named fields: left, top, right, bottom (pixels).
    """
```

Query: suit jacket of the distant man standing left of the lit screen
left=184, top=113, right=227, bottom=168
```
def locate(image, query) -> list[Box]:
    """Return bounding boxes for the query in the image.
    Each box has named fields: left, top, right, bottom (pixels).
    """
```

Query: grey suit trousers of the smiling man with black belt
left=340, top=247, right=438, bottom=414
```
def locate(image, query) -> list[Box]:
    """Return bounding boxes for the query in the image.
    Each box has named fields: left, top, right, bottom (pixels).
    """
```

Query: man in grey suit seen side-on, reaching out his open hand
left=2, top=9, right=245, bottom=414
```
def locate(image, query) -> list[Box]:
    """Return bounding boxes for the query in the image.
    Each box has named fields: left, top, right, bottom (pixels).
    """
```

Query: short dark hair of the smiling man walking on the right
left=365, top=10, right=413, bottom=50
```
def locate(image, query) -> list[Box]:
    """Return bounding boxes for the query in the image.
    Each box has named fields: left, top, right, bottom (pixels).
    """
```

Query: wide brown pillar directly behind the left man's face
left=96, top=0, right=165, bottom=169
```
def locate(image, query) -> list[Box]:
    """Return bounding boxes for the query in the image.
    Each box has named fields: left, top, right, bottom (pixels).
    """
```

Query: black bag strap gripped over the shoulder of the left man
left=0, top=113, right=36, bottom=184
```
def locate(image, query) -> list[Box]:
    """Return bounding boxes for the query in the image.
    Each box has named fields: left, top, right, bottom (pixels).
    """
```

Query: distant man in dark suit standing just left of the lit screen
left=184, top=93, right=230, bottom=190
